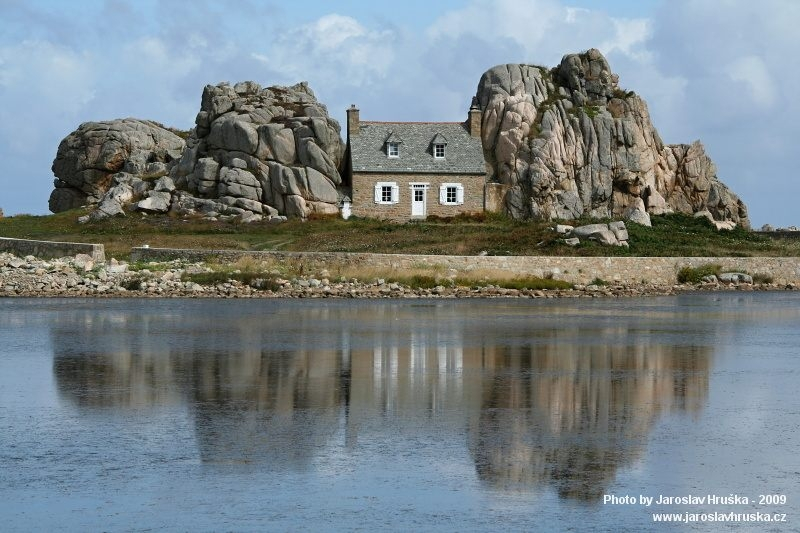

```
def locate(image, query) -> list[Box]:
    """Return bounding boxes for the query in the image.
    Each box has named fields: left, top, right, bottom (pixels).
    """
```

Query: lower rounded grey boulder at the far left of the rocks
left=49, top=118, right=186, bottom=213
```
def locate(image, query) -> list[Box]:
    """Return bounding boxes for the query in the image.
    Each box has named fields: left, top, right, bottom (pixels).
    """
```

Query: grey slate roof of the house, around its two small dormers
left=350, top=122, right=486, bottom=174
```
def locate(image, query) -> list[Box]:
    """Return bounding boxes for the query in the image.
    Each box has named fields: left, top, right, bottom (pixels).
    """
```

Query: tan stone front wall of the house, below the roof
left=352, top=173, right=485, bottom=221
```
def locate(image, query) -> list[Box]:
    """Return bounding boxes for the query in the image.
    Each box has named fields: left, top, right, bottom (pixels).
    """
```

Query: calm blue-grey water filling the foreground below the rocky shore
left=0, top=293, right=800, bottom=531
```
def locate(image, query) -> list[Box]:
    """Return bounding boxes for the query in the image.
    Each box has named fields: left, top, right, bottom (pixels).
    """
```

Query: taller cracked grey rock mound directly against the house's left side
left=175, top=82, right=344, bottom=217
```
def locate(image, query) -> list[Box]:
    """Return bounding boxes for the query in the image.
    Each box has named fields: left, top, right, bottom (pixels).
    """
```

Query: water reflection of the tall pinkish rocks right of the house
left=470, top=343, right=710, bottom=500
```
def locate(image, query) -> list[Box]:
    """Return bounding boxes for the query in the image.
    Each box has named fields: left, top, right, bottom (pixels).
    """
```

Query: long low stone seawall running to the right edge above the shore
left=131, top=248, right=800, bottom=285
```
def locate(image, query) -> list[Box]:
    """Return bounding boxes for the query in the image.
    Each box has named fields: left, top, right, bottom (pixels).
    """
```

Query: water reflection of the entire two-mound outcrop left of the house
left=51, top=302, right=349, bottom=467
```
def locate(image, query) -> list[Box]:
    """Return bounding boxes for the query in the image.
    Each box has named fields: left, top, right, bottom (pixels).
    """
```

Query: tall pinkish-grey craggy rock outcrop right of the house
left=476, top=49, right=749, bottom=227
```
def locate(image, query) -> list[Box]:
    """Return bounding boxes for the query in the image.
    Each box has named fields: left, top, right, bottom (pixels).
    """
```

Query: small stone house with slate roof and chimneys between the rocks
left=345, top=105, right=486, bottom=221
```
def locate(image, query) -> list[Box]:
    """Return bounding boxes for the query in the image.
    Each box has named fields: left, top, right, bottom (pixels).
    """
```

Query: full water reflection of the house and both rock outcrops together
left=52, top=304, right=710, bottom=500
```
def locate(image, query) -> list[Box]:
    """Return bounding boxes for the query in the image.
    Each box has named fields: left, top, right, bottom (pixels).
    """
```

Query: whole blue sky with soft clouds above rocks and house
left=0, top=0, right=800, bottom=227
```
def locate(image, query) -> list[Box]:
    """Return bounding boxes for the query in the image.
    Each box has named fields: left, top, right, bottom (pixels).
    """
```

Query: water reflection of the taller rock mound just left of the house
left=192, top=344, right=348, bottom=469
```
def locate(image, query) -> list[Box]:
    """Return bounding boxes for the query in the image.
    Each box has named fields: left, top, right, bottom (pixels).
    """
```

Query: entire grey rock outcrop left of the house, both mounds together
left=50, top=82, right=344, bottom=221
